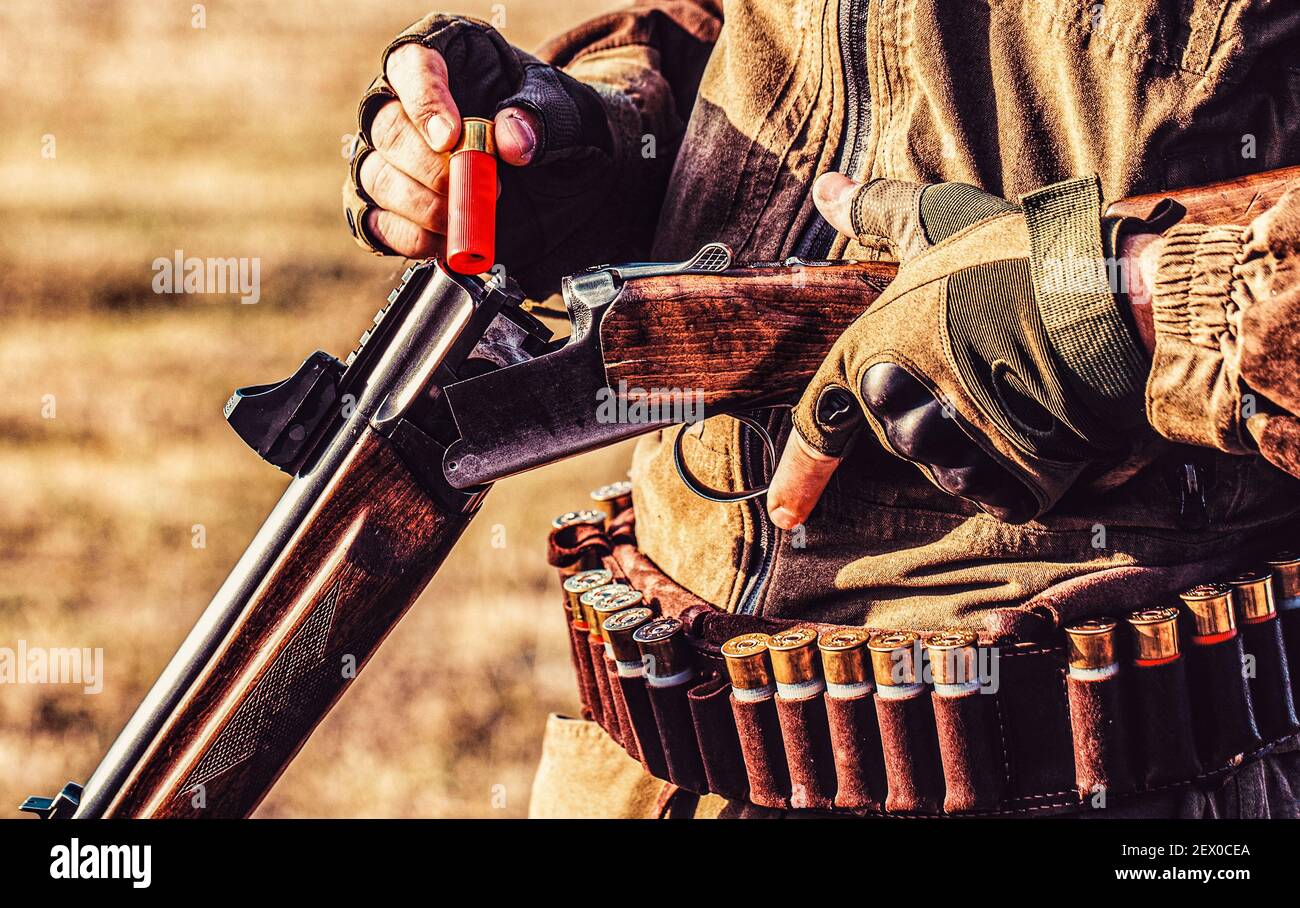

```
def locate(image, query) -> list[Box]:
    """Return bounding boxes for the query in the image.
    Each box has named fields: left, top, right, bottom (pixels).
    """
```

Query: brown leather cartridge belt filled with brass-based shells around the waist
left=549, top=487, right=1300, bottom=816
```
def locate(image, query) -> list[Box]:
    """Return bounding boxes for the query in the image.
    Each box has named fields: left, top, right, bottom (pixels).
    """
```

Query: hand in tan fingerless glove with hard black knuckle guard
left=767, top=173, right=1158, bottom=529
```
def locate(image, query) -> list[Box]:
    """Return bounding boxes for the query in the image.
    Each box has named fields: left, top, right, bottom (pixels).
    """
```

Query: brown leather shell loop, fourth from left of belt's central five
left=875, top=684, right=944, bottom=813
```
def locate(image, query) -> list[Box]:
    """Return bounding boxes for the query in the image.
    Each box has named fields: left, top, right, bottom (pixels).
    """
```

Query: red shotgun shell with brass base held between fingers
left=447, top=117, right=497, bottom=274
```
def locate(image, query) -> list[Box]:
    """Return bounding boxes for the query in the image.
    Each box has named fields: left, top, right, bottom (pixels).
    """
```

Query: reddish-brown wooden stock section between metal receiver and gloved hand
left=601, top=261, right=897, bottom=412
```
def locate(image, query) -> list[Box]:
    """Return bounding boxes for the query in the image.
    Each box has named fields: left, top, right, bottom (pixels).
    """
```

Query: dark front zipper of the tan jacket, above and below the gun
left=736, top=0, right=871, bottom=615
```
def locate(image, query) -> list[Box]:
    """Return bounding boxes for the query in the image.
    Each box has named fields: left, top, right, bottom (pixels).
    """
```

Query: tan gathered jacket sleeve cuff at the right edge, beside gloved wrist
left=1147, top=186, right=1300, bottom=476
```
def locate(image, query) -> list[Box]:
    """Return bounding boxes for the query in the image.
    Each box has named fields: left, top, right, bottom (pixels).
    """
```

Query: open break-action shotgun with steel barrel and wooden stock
left=23, top=168, right=1300, bottom=818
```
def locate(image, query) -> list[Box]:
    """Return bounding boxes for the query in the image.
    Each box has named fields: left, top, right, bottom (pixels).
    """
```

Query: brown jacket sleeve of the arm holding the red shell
left=537, top=0, right=723, bottom=256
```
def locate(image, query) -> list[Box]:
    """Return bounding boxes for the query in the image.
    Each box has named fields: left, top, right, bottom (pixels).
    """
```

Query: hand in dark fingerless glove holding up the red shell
left=343, top=14, right=615, bottom=297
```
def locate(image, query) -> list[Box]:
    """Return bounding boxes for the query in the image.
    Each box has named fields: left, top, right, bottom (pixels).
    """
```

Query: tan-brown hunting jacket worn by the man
left=520, top=0, right=1300, bottom=813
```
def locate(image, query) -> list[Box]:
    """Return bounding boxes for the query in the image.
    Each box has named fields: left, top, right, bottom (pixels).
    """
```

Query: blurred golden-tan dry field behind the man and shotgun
left=0, top=0, right=627, bottom=817
